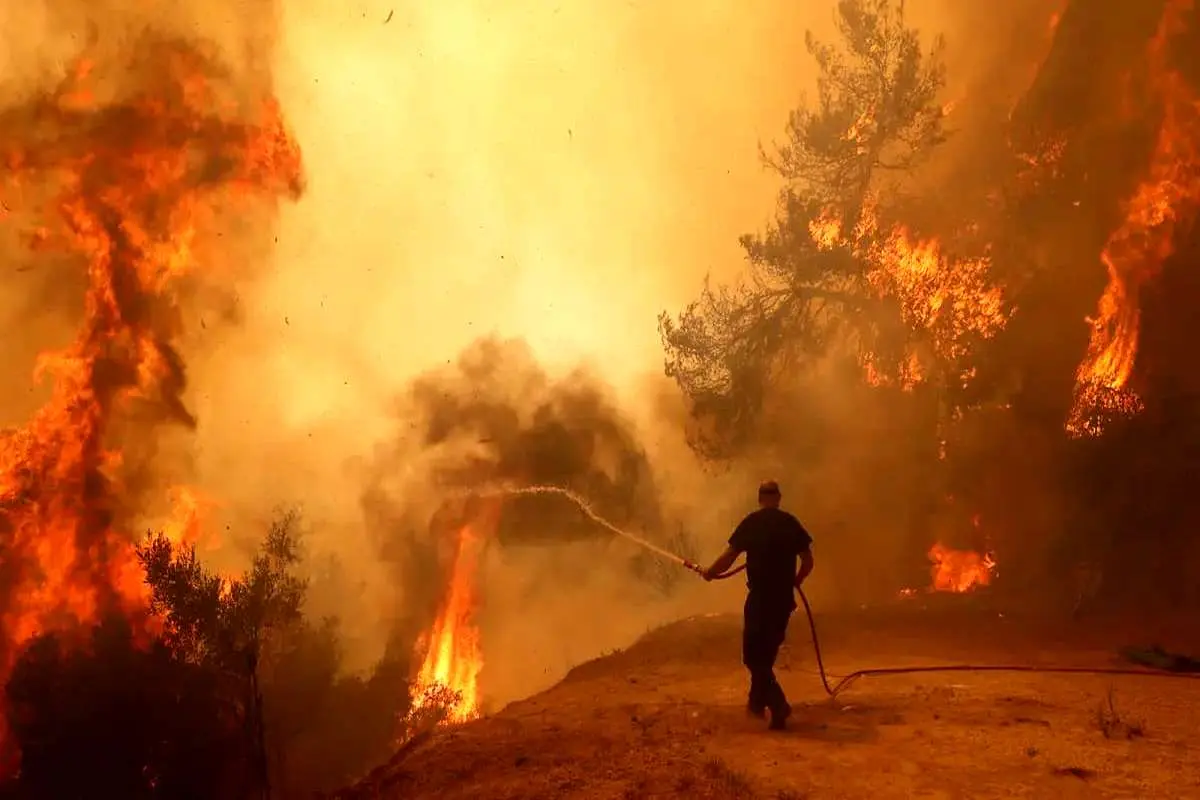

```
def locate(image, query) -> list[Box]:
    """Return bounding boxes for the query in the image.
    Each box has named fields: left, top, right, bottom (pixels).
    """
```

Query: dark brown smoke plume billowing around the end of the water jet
left=364, top=338, right=683, bottom=638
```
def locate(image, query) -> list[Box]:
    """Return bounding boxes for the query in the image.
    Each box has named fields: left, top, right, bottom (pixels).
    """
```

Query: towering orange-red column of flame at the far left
left=0, top=37, right=301, bottom=762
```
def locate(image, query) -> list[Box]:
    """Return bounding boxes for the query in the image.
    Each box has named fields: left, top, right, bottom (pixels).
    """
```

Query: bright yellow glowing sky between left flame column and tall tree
left=237, top=0, right=825, bottom=413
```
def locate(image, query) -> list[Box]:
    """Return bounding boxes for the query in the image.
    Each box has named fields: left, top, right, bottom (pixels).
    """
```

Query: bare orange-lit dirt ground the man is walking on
left=333, top=597, right=1200, bottom=800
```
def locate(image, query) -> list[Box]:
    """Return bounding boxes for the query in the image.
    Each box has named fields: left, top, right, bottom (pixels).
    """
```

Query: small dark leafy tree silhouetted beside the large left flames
left=139, top=512, right=408, bottom=798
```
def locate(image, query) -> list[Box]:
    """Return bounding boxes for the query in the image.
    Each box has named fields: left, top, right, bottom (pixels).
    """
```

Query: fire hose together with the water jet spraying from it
left=492, top=486, right=1200, bottom=698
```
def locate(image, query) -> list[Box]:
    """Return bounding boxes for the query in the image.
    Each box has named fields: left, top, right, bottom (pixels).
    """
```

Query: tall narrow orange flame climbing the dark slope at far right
left=1067, top=0, right=1200, bottom=437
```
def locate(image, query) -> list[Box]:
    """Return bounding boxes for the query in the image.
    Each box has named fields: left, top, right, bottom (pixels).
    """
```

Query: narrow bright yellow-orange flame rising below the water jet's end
left=412, top=504, right=497, bottom=723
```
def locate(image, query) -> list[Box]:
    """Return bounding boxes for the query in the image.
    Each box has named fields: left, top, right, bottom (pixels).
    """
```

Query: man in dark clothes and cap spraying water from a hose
left=702, top=481, right=812, bottom=730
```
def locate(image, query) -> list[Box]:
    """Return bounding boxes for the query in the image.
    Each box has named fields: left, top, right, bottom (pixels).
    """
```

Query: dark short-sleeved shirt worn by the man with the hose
left=730, top=507, right=812, bottom=608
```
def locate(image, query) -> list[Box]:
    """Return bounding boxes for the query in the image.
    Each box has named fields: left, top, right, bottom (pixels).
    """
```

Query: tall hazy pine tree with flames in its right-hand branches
left=659, top=0, right=964, bottom=455
